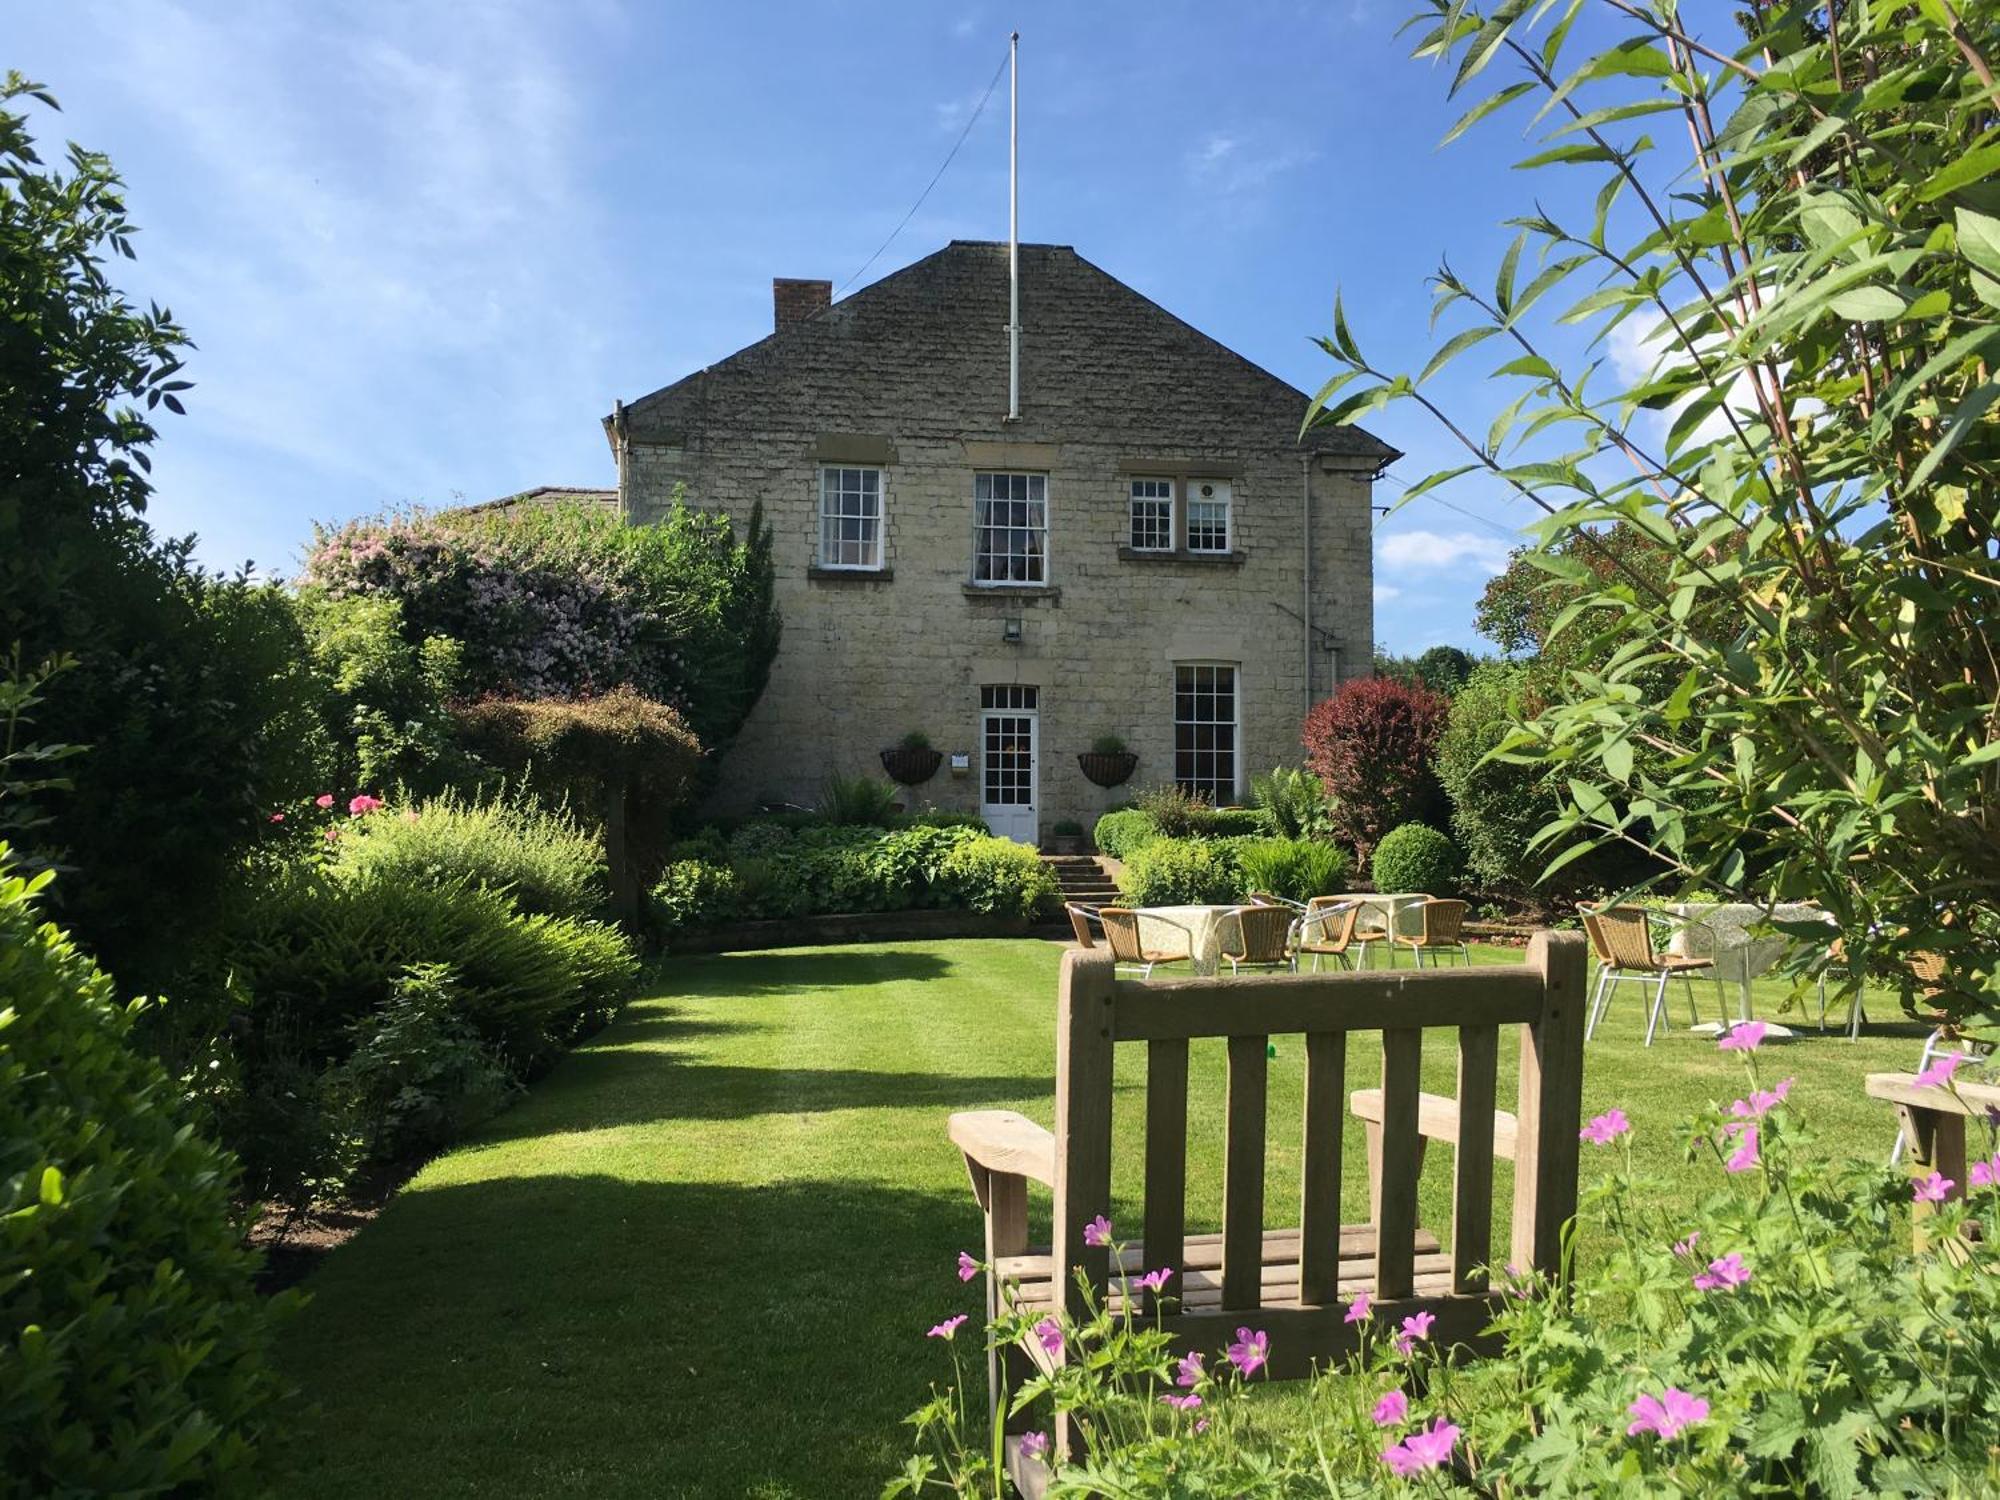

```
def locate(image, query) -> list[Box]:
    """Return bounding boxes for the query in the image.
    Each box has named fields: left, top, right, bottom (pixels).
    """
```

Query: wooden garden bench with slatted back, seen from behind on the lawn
left=950, top=932, right=1586, bottom=1492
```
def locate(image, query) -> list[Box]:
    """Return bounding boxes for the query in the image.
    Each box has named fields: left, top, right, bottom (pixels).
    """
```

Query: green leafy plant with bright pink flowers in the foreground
left=908, top=1024, right=2000, bottom=1496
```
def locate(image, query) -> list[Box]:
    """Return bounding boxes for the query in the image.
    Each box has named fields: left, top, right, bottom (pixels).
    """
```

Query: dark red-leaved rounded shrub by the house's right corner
left=1302, top=678, right=1450, bottom=864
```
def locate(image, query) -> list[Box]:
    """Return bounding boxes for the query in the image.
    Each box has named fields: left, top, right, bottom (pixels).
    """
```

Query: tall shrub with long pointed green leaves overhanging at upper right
left=1314, top=0, right=2000, bottom=1018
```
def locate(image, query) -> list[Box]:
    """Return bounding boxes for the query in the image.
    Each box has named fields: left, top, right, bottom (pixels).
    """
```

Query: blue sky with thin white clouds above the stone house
left=0, top=0, right=1600, bottom=652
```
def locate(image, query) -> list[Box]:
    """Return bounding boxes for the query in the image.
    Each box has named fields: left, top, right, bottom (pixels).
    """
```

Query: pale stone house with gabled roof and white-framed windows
left=604, top=240, right=1398, bottom=842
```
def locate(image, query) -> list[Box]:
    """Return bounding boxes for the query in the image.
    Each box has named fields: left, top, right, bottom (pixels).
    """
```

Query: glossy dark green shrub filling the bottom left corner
left=0, top=844, right=290, bottom=1496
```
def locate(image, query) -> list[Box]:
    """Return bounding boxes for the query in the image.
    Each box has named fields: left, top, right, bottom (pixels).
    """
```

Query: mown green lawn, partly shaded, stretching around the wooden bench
left=278, top=940, right=1920, bottom=1498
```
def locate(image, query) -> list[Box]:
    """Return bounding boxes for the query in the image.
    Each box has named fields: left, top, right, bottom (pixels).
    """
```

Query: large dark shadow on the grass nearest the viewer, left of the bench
left=280, top=1176, right=984, bottom=1496
